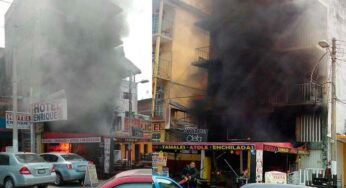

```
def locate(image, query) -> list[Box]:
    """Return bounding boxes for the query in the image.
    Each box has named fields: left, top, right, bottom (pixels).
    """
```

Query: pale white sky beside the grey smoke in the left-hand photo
left=0, top=0, right=152, bottom=100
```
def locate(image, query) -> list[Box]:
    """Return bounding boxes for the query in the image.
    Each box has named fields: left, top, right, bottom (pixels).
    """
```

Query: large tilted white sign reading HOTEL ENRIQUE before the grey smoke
left=32, top=99, right=67, bottom=122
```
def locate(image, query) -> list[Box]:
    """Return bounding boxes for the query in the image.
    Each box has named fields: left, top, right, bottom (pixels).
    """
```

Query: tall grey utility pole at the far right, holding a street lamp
left=330, top=38, right=337, bottom=183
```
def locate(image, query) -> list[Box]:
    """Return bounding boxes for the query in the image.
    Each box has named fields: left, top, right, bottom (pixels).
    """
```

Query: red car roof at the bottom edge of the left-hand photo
left=101, top=169, right=153, bottom=188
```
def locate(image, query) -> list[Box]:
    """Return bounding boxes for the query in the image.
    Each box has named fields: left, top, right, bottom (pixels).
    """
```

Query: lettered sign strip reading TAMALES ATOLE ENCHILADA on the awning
left=158, top=145, right=255, bottom=150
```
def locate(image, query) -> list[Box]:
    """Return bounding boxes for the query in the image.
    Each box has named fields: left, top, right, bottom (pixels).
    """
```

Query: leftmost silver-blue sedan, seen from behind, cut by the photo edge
left=0, top=152, right=56, bottom=188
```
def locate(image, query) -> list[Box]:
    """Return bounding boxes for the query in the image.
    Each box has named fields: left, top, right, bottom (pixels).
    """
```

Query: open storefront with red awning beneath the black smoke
left=153, top=142, right=308, bottom=186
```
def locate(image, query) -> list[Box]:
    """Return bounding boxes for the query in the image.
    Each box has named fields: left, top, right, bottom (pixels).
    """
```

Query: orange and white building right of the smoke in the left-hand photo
left=114, top=79, right=152, bottom=164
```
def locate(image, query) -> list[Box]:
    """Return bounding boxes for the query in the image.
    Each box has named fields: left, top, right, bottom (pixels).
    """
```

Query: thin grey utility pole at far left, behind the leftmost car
left=12, top=47, right=18, bottom=152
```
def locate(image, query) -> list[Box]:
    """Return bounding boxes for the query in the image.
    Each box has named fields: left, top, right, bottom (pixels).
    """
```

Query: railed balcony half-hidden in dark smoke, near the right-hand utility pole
left=269, top=83, right=323, bottom=106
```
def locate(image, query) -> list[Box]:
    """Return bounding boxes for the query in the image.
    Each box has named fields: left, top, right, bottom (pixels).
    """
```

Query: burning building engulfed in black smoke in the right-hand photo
left=192, top=0, right=345, bottom=183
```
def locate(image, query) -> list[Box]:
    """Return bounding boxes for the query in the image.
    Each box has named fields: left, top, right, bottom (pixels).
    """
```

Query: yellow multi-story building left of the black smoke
left=152, top=0, right=209, bottom=141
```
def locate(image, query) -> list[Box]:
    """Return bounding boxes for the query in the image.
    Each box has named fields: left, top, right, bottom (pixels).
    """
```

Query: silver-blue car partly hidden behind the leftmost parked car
left=41, top=152, right=88, bottom=185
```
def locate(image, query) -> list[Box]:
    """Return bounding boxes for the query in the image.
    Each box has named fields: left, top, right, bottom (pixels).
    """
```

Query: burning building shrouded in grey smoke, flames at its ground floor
left=5, top=0, right=138, bottom=176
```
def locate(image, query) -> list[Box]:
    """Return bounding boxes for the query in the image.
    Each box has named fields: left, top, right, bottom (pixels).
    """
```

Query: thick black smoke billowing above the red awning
left=194, top=0, right=323, bottom=141
